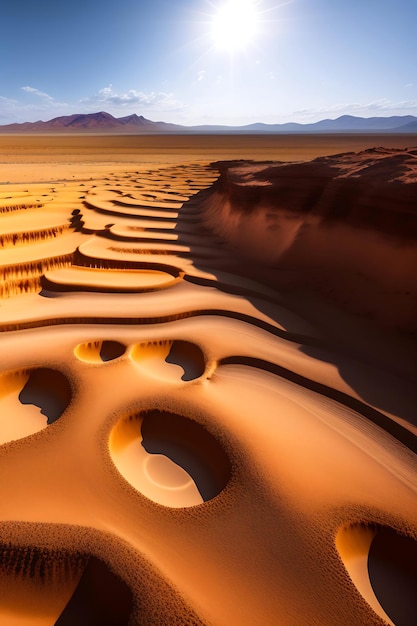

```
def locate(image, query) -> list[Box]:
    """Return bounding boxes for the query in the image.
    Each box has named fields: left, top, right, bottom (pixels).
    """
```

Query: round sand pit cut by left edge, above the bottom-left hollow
left=0, top=367, right=72, bottom=444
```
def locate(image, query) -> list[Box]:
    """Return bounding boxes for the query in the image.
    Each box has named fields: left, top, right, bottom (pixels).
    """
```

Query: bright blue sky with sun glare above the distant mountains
left=0, top=0, right=417, bottom=124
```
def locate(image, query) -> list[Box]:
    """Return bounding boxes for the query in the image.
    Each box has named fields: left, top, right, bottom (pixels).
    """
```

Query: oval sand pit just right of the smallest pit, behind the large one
left=131, top=340, right=206, bottom=381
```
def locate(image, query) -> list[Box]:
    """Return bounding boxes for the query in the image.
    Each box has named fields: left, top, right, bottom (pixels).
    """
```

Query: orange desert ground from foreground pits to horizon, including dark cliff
left=0, top=135, right=417, bottom=626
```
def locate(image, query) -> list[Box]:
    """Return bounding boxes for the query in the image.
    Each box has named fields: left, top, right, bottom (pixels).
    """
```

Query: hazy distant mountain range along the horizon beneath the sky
left=0, top=111, right=417, bottom=134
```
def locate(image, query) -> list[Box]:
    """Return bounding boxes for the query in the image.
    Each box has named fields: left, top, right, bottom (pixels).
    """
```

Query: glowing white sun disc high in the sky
left=211, top=0, right=259, bottom=52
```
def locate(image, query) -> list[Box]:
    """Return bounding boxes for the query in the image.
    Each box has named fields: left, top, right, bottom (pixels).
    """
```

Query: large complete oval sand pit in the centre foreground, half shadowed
left=110, top=409, right=230, bottom=508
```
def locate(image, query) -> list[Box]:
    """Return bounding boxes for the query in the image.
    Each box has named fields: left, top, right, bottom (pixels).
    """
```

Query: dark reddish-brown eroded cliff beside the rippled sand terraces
left=203, top=148, right=417, bottom=334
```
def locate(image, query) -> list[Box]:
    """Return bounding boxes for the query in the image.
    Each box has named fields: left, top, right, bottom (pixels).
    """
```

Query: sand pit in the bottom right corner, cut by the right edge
left=336, top=524, right=417, bottom=626
